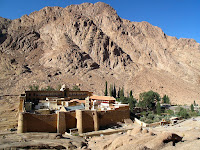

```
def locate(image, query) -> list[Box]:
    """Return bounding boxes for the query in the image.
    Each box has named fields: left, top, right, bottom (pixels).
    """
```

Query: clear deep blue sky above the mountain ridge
left=0, top=0, right=200, bottom=43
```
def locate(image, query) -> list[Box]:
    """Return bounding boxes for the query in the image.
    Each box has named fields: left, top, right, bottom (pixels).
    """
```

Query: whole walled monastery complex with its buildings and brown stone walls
left=18, top=87, right=130, bottom=133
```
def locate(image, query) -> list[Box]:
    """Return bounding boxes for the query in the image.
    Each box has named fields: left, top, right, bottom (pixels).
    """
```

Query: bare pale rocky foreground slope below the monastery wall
left=0, top=120, right=200, bottom=150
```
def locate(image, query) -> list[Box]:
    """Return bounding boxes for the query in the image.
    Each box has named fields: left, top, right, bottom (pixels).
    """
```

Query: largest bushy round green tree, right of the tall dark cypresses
left=139, top=91, right=160, bottom=110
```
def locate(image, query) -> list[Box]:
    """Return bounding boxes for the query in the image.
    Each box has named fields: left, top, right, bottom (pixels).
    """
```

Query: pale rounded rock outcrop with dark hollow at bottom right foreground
left=88, top=127, right=183, bottom=150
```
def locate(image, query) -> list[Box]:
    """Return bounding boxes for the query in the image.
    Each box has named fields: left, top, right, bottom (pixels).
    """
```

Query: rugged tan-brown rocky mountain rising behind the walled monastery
left=0, top=2, right=200, bottom=104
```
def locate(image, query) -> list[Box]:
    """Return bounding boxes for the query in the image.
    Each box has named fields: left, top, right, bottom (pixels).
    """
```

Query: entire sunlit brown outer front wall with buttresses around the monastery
left=18, top=109, right=130, bottom=133
